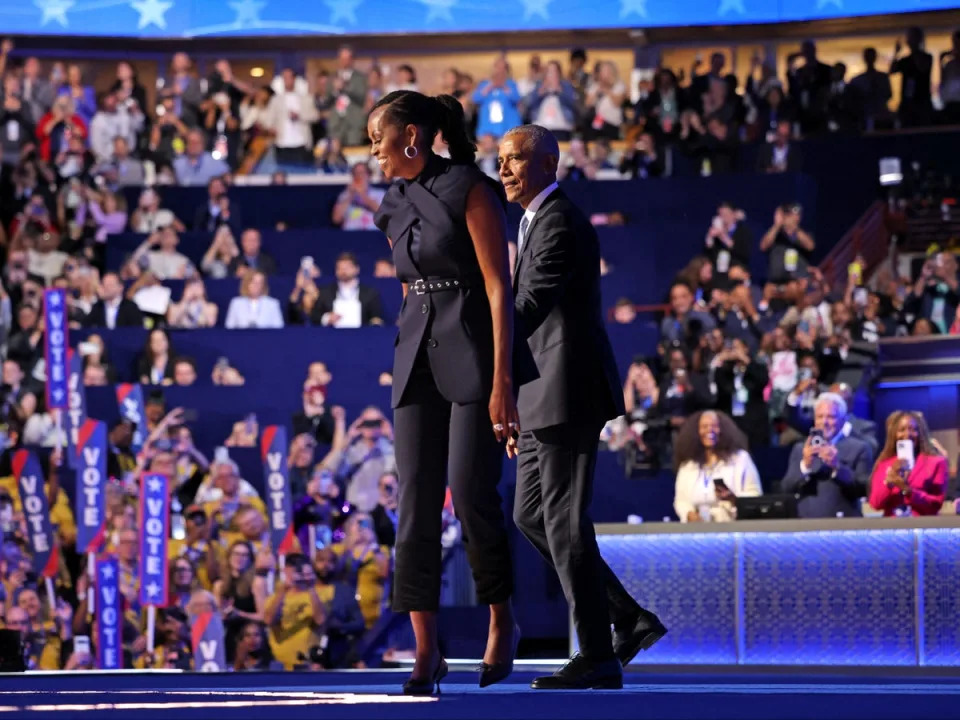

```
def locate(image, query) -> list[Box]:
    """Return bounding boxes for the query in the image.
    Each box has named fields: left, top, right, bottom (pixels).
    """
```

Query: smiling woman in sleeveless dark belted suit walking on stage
left=367, top=90, right=532, bottom=694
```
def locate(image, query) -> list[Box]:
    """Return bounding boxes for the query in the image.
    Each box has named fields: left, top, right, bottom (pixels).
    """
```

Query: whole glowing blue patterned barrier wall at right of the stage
left=598, top=519, right=960, bottom=666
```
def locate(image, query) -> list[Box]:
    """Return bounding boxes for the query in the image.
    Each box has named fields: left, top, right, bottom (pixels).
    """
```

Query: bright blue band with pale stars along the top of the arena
left=0, top=0, right=956, bottom=37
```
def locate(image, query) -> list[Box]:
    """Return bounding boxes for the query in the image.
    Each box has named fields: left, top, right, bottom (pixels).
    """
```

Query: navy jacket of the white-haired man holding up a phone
left=781, top=437, right=873, bottom=518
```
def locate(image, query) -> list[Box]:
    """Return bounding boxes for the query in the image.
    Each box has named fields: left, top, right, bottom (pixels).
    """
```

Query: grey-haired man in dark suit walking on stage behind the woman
left=499, top=125, right=666, bottom=689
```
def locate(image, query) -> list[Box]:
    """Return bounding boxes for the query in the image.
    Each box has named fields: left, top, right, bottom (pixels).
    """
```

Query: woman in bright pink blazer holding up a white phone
left=870, top=411, right=948, bottom=516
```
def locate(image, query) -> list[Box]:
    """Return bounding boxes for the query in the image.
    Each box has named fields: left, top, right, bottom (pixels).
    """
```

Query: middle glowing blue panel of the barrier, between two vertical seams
left=740, top=530, right=917, bottom=665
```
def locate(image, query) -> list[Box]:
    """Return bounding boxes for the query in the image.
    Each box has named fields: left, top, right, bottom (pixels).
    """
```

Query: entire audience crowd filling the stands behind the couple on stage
left=0, top=29, right=960, bottom=670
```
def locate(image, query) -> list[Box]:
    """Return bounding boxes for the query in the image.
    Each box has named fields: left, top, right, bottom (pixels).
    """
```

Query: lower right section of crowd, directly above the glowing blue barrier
left=603, top=197, right=960, bottom=522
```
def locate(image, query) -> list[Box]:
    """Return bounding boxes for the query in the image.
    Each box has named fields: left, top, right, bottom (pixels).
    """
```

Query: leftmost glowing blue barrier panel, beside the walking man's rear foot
left=597, top=534, right=737, bottom=664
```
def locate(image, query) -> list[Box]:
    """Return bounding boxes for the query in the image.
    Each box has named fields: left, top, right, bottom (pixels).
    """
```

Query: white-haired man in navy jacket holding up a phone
left=781, top=393, right=873, bottom=518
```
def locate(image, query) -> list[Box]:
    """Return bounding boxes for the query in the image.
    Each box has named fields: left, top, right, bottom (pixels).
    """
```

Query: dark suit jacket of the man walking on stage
left=513, top=189, right=624, bottom=430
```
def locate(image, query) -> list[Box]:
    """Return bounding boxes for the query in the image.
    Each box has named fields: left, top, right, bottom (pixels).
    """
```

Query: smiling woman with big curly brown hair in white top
left=673, top=410, right=763, bottom=522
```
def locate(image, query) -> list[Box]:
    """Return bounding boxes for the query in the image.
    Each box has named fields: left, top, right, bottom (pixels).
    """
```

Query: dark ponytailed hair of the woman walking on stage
left=371, top=90, right=477, bottom=165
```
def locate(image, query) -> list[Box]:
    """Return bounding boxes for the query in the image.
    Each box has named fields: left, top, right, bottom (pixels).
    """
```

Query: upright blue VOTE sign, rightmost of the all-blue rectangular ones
left=140, top=473, right=170, bottom=607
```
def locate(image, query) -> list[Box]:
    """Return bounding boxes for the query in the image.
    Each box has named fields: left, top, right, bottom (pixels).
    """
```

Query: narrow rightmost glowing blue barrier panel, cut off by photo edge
left=920, top=530, right=960, bottom=666
